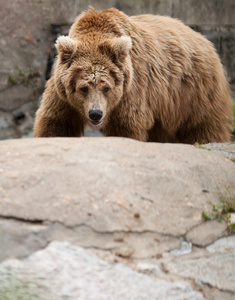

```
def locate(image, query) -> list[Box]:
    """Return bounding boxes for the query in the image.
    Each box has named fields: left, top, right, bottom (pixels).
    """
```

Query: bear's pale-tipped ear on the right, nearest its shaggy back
left=99, top=36, right=132, bottom=63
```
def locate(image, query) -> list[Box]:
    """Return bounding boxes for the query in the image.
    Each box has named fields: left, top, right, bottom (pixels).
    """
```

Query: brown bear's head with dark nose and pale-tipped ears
left=54, top=36, right=133, bottom=127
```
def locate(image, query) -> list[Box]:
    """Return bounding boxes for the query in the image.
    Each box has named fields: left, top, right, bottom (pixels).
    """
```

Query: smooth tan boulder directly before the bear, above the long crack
left=0, top=138, right=235, bottom=236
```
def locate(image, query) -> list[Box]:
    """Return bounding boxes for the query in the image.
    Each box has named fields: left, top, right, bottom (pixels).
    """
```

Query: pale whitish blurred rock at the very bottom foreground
left=0, top=242, right=205, bottom=300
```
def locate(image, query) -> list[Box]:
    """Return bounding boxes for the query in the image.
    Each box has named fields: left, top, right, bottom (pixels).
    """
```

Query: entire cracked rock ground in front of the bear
left=0, top=137, right=235, bottom=300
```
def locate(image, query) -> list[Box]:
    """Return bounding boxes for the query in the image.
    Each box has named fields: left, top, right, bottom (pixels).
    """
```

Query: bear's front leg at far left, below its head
left=34, top=78, right=84, bottom=137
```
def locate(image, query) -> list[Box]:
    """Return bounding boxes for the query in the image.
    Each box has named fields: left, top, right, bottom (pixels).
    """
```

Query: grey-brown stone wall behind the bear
left=0, top=0, right=235, bottom=139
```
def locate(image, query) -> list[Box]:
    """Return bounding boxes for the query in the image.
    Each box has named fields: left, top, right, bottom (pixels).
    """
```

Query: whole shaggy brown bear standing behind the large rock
left=34, top=8, right=232, bottom=144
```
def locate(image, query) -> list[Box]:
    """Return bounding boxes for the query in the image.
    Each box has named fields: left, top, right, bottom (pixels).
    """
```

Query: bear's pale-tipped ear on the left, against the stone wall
left=55, top=35, right=77, bottom=63
